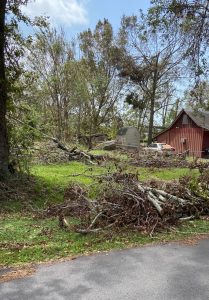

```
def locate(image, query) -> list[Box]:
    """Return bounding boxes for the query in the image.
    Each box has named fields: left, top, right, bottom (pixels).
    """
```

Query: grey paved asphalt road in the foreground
left=0, top=240, right=209, bottom=300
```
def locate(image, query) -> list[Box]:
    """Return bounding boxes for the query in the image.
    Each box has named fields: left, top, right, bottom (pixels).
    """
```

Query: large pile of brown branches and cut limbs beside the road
left=46, top=173, right=209, bottom=234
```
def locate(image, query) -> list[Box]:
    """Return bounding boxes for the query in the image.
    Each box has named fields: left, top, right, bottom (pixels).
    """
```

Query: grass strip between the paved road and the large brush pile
left=0, top=215, right=209, bottom=267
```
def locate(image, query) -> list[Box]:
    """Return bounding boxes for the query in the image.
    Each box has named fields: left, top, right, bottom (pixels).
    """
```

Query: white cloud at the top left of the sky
left=22, top=0, right=88, bottom=26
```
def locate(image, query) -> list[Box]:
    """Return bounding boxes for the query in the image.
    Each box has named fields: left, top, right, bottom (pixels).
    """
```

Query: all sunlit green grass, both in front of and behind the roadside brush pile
left=0, top=162, right=209, bottom=266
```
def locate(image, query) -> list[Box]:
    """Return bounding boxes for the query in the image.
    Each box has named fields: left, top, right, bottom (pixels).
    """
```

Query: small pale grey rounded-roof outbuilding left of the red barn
left=116, top=127, right=140, bottom=149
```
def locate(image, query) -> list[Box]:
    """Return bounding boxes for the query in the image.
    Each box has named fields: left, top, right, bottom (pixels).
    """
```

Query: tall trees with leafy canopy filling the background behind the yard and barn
left=0, top=0, right=208, bottom=175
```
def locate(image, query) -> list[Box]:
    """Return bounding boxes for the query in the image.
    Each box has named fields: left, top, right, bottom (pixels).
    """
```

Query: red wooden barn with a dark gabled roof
left=155, top=109, right=209, bottom=157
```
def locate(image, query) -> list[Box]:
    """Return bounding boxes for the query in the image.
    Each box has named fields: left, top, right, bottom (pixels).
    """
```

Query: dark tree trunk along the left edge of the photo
left=0, top=0, right=9, bottom=178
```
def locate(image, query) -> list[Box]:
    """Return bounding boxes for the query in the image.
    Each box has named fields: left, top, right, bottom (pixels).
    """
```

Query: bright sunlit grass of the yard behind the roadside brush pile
left=31, top=162, right=198, bottom=187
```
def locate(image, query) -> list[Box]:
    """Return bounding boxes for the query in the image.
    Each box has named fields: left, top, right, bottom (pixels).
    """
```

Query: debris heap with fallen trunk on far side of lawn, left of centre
left=34, top=139, right=105, bottom=164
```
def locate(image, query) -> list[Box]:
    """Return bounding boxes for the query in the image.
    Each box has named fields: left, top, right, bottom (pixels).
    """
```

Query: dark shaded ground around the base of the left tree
left=0, top=174, right=65, bottom=213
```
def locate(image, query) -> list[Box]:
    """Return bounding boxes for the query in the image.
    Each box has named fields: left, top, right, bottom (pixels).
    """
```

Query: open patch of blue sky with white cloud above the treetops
left=23, top=0, right=150, bottom=37
